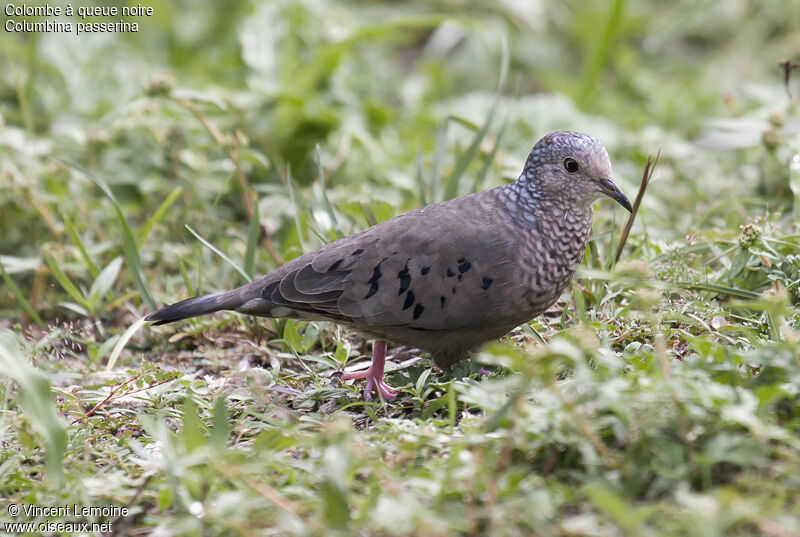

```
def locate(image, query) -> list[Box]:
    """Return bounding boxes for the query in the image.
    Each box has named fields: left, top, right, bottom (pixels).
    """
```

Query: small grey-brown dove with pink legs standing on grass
left=145, top=131, right=632, bottom=401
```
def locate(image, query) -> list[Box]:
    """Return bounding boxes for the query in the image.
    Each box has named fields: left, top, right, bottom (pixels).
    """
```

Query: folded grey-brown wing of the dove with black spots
left=237, top=191, right=520, bottom=330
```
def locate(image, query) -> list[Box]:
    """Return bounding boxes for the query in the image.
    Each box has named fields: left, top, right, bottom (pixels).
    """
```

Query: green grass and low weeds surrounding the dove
left=0, top=0, right=800, bottom=537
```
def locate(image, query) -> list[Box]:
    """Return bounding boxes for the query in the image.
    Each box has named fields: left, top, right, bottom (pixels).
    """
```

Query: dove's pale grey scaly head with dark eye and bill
left=521, top=131, right=631, bottom=212
